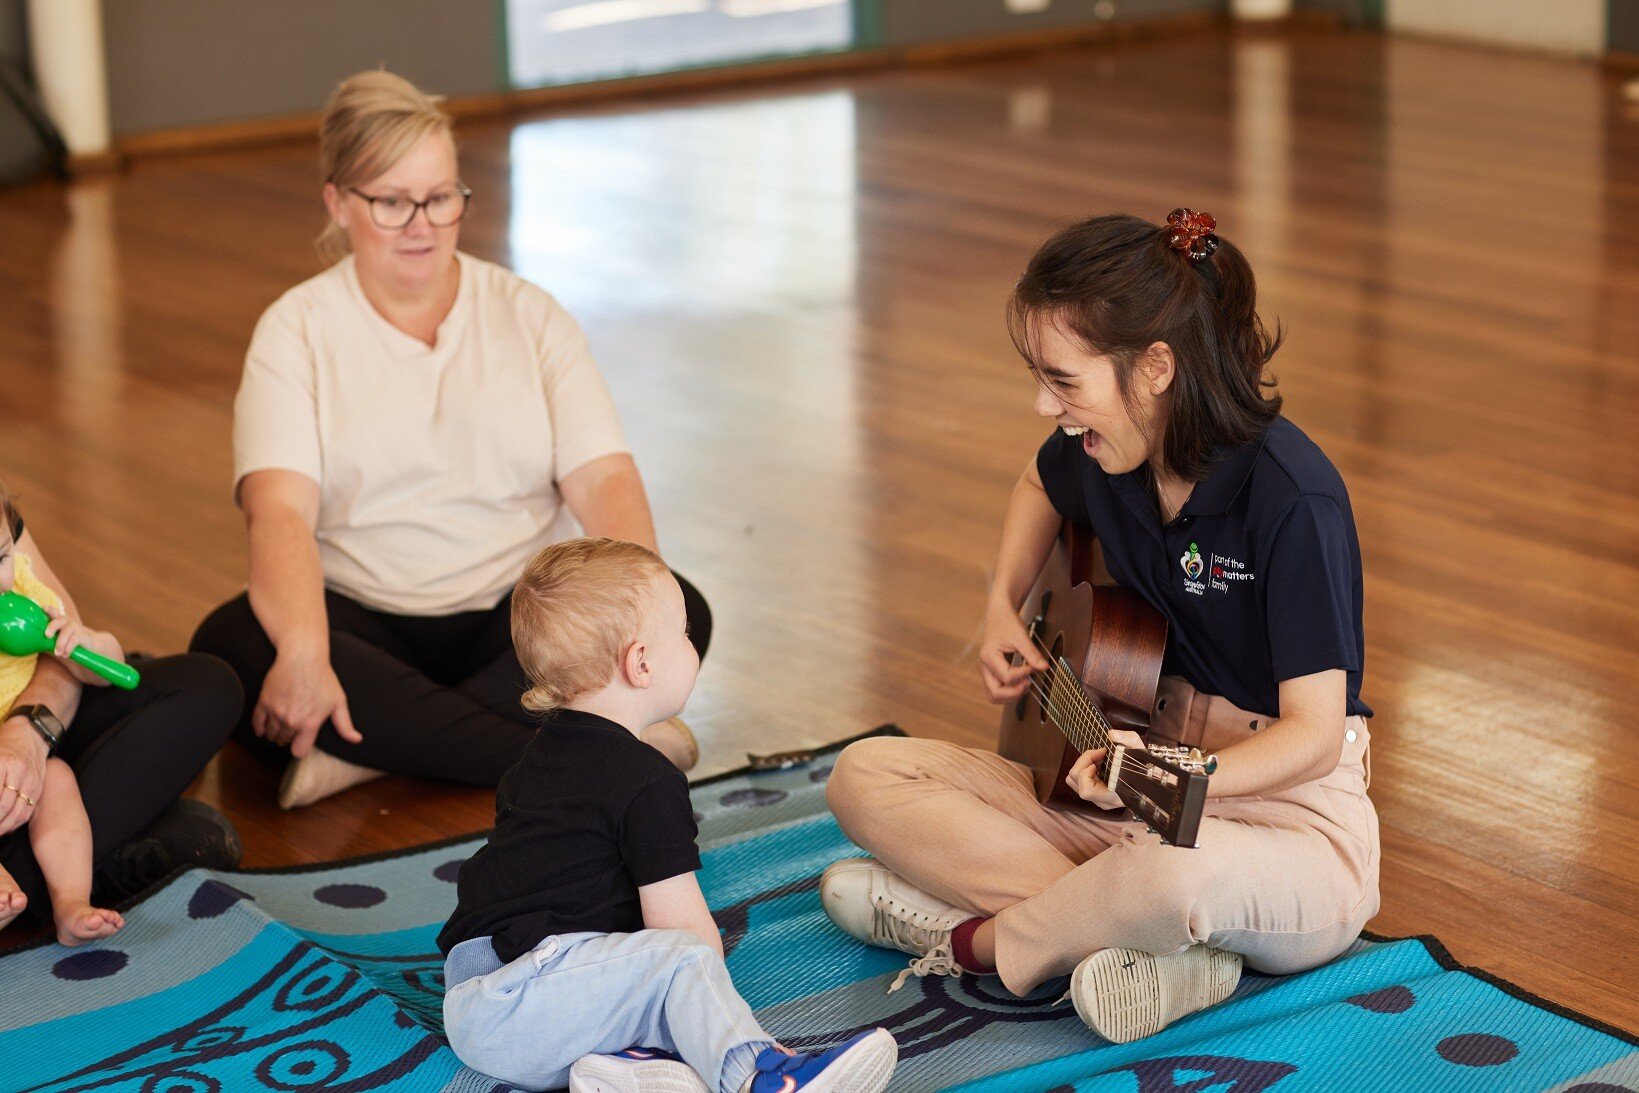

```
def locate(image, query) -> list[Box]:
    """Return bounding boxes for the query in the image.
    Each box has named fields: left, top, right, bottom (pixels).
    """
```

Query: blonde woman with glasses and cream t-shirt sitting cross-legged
left=193, top=72, right=711, bottom=808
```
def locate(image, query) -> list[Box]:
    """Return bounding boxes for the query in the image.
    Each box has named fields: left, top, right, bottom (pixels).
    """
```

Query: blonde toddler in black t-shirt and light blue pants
left=438, top=539, right=898, bottom=1093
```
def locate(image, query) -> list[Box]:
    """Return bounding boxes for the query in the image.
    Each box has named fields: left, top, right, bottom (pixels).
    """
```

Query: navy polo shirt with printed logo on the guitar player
left=1036, top=418, right=1372, bottom=718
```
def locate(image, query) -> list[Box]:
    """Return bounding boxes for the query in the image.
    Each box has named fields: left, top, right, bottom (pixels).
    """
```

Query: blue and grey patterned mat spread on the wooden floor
left=0, top=729, right=1639, bottom=1093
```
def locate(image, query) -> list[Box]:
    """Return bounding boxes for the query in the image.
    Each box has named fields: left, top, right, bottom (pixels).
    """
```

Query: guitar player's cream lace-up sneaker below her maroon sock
left=820, top=857, right=974, bottom=995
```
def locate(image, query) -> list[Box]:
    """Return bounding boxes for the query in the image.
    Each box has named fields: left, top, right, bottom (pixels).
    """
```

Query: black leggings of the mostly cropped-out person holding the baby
left=0, top=654, right=244, bottom=916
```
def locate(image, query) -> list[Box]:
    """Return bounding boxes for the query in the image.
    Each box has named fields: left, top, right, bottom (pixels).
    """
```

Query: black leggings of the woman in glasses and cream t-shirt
left=190, top=577, right=711, bottom=785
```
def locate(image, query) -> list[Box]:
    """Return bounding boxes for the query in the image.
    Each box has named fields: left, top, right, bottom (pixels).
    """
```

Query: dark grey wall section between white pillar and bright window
left=103, top=0, right=503, bottom=134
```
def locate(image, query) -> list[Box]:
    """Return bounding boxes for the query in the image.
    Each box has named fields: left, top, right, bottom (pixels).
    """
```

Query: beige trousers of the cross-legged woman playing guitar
left=828, top=677, right=1378, bottom=995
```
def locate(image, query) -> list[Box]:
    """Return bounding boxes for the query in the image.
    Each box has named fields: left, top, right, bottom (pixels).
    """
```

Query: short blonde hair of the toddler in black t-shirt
left=511, top=539, right=670, bottom=713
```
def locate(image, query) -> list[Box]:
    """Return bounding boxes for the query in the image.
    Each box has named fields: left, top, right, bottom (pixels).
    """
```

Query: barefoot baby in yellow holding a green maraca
left=0, top=483, right=136, bottom=946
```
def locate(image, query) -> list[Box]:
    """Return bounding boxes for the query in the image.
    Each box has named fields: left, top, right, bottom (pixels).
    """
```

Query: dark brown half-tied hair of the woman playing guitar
left=1008, top=215, right=1283, bottom=482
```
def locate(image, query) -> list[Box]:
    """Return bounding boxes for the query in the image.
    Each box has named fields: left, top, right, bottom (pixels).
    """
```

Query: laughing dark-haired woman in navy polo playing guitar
left=821, top=210, right=1378, bottom=1042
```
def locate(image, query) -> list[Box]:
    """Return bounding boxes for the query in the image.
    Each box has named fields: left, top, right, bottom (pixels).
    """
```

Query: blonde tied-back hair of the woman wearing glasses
left=318, top=70, right=451, bottom=262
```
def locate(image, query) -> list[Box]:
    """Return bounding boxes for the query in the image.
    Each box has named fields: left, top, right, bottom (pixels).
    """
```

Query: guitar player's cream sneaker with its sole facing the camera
left=1070, top=946, right=1241, bottom=1044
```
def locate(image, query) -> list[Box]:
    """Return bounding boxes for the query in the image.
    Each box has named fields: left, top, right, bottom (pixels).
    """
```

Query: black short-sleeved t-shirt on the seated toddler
left=438, top=710, right=700, bottom=960
